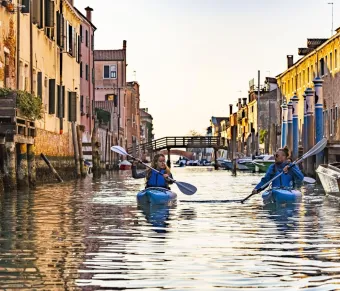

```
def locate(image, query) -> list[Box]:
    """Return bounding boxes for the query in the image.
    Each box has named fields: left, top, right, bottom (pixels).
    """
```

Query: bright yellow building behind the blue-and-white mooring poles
left=277, top=34, right=340, bottom=140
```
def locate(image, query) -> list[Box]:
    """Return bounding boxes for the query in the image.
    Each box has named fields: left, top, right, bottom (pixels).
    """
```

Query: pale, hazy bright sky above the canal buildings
left=74, top=0, right=340, bottom=138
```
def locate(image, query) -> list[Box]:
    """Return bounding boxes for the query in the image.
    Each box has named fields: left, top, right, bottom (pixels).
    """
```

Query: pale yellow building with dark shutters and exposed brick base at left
left=17, top=0, right=81, bottom=160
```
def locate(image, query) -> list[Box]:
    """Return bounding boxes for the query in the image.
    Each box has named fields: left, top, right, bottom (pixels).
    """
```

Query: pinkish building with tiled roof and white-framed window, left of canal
left=94, top=40, right=127, bottom=147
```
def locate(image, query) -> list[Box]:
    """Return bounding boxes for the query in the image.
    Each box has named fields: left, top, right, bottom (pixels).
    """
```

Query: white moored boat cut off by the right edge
left=316, top=163, right=340, bottom=196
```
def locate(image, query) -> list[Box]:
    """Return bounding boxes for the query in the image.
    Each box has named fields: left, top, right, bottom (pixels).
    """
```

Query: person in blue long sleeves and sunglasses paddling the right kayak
left=252, top=146, right=304, bottom=194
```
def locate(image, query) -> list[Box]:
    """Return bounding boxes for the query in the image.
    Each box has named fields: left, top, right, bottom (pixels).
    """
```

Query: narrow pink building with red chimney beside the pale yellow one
left=74, top=7, right=96, bottom=142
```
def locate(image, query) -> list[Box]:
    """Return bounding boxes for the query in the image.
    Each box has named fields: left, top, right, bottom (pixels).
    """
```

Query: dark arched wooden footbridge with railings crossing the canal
left=128, top=136, right=225, bottom=154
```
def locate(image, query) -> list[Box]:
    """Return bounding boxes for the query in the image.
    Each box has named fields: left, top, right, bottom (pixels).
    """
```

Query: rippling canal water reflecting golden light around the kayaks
left=0, top=167, right=340, bottom=291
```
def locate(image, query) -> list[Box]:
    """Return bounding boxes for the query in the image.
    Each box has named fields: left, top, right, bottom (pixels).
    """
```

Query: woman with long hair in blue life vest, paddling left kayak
left=131, top=154, right=173, bottom=189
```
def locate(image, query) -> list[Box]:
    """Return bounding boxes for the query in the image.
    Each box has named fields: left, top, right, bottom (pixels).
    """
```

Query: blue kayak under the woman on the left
left=137, top=187, right=177, bottom=204
